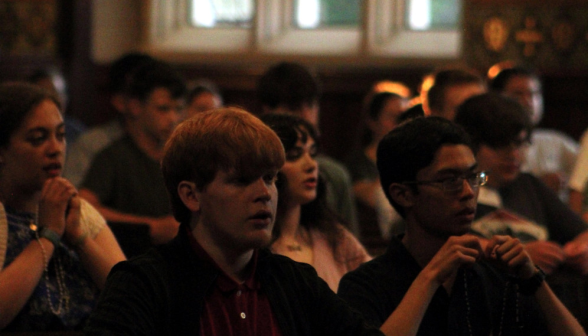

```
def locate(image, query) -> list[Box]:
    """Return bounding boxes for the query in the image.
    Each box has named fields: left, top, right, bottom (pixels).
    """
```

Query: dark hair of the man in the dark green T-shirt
left=126, top=61, right=186, bottom=101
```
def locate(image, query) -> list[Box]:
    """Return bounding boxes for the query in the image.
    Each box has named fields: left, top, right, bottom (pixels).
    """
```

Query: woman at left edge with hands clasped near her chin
left=0, top=83, right=125, bottom=333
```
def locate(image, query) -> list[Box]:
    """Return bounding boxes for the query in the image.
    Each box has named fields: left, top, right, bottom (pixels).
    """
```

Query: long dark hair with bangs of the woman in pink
left=261, top=113, right=343, bottom=262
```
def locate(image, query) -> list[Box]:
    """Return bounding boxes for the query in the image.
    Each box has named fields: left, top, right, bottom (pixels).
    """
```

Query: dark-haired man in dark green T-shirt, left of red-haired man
left=80, top=61, right=186, bottom=245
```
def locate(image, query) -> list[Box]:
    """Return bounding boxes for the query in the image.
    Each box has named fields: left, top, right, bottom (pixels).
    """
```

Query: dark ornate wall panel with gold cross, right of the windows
left=463, top=0, right=588, bottom=71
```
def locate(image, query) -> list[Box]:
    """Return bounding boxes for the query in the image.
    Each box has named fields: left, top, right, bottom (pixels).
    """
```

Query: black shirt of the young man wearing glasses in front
left=338, top=238, right=547, bottom=335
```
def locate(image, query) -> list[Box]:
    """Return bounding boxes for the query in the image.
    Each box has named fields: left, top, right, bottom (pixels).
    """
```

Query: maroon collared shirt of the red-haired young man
left=188, top=228, right=281, bottom=336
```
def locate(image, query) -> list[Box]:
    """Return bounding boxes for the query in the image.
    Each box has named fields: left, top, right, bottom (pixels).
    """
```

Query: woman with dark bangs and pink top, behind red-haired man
left=261, top=113, right=371, bottom=291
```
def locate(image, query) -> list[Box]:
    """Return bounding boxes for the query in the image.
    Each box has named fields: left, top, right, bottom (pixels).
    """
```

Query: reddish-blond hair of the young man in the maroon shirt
left=161, top=107, right=285, bottom=223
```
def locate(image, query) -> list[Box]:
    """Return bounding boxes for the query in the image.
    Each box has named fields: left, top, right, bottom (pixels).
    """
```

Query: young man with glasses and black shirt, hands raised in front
left=338, top=117, right=584, bottom=335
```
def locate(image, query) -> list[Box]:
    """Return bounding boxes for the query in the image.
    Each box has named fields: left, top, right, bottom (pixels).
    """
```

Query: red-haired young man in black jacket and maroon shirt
left=86, top=108, right=381, bottom=336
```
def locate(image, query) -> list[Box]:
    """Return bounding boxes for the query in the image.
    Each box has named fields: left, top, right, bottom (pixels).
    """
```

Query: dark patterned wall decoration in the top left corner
left=0, top=0, right=57, bottom=56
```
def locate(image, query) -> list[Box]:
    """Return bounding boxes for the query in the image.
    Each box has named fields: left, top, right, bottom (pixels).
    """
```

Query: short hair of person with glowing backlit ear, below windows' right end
left=427, top=69, right=485, bottom=111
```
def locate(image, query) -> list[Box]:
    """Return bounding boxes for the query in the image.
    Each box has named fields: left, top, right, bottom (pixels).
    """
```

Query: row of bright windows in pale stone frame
left=103, top=0, right=462, bottom=65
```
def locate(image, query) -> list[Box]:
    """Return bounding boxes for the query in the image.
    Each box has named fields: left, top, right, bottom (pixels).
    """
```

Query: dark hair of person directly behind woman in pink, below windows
left=257, top=62, right=321, bottom=111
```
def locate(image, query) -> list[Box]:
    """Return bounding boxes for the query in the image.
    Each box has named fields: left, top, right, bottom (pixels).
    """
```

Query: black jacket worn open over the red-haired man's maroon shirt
left=86, top=227, right=382, bottom=336
